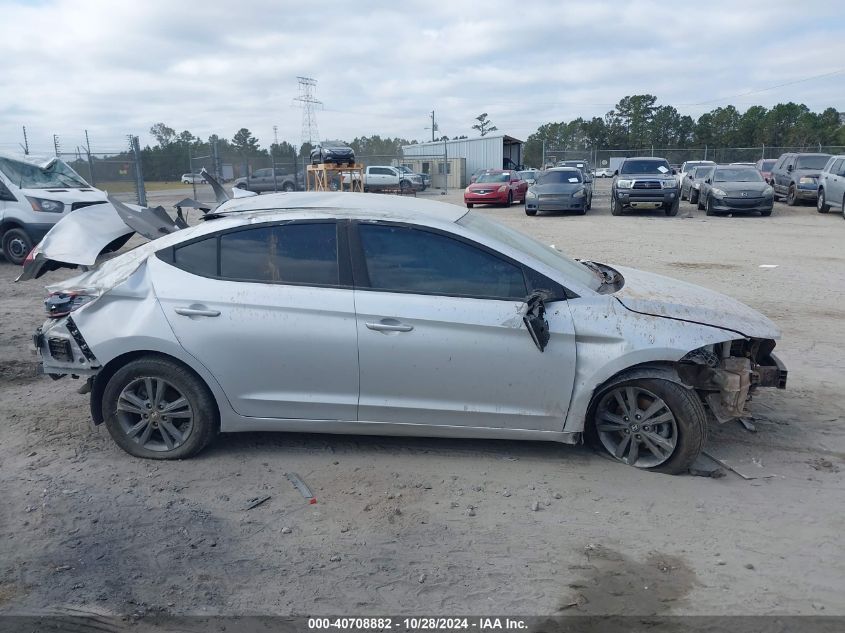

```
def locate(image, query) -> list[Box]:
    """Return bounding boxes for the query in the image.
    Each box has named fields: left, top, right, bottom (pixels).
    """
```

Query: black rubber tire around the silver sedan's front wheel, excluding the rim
left=584, top=377, right=707, bottom=475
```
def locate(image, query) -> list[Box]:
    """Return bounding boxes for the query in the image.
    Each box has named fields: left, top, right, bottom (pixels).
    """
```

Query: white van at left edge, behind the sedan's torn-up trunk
left=0, top=153, right=108, bottom=264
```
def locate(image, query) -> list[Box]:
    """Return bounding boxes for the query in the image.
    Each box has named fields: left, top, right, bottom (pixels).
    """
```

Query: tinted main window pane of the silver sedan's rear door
left=220, top=222, right=339, bottom=286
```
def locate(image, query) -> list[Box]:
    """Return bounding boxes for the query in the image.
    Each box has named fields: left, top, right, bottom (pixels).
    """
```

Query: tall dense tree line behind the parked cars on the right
left=524, top=94, right=845, bottom=165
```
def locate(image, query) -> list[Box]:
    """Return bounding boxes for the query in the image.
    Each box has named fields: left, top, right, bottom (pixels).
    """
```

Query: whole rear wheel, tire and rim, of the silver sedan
left=102, top=357, right=218, bottom=459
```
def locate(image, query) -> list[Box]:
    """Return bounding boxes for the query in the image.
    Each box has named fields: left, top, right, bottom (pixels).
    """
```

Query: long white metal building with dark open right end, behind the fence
left=402, top=134, right=524, bottom=187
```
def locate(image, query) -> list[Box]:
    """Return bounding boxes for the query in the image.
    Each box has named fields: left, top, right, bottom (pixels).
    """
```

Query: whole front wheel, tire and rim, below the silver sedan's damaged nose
left=586, top=378, right=707, bottom=475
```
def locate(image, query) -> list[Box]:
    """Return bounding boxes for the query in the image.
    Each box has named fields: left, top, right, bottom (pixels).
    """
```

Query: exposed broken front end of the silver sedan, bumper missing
left=676, top=339, right=787, bottom=423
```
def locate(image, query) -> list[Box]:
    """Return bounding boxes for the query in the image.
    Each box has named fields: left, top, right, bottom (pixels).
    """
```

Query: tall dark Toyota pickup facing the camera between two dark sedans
left=610, top=156, right=680, bottom=215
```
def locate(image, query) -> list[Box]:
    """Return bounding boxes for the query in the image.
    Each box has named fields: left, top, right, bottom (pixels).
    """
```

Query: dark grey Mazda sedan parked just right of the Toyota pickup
left=698, top=165, right=775, bottom=217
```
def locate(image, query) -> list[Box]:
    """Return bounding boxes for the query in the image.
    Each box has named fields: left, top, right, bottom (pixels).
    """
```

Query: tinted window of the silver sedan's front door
left=358, top=224, right=527, bottom=299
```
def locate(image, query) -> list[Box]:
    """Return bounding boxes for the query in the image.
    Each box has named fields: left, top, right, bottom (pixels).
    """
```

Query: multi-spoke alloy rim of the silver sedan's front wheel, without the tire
left=595, top=385, right=678, bottom=468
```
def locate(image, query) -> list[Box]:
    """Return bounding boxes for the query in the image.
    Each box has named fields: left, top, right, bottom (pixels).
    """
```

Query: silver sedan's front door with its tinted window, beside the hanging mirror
left=353, top=223, right=575, bottom=431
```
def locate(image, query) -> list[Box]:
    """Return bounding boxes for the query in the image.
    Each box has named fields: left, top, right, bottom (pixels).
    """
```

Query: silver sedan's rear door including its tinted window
left=150, top=222, right=358, bottom=420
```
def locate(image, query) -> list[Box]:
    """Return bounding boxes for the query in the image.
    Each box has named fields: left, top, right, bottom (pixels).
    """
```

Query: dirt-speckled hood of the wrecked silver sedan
left=614, top=266, right=780, bottom=339
